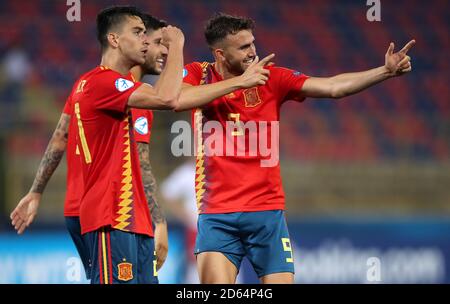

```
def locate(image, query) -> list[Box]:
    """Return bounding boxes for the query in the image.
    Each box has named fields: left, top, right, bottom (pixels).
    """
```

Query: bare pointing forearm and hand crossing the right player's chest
left=175, top=54, right=275, bottom=111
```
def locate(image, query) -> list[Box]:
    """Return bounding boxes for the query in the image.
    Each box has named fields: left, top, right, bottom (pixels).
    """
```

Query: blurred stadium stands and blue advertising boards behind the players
left=0, top=0, right=450, bottom=283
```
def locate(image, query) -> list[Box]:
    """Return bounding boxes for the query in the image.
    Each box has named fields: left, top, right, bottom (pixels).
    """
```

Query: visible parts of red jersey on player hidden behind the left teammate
left=63, top=97, right=153, bottom=216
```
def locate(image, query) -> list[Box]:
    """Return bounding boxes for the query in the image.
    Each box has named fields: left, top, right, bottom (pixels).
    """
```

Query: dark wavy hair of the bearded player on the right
left=205, top=13, right=255, bottom=47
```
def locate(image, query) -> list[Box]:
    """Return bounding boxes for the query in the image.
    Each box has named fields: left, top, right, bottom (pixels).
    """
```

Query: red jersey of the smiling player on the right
left=183, top=62, right=308, bottom=213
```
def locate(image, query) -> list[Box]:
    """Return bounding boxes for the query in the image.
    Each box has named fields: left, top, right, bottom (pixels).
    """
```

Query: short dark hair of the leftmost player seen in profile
left=97, top=6, right=142, bottom=51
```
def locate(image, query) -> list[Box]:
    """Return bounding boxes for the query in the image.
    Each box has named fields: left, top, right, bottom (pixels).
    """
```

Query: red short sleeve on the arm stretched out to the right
left=271, top=67, right=309, bottom=102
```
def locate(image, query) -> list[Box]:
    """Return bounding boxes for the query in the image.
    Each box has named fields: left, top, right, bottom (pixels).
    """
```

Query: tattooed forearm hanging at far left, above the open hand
left=30, top=114, right=70, bottom=193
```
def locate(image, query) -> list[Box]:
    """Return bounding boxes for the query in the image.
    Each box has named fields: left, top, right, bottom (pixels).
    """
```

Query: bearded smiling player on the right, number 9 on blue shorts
left=179, top=13, right=415, bottom=283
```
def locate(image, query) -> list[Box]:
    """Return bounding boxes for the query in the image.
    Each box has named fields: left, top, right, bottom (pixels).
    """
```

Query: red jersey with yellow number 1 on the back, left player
left=71, top=67, right=153, bottom=236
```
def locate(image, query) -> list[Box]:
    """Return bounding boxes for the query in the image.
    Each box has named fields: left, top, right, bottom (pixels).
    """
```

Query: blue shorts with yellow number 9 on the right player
left=194, top=210, right=294, bottom=278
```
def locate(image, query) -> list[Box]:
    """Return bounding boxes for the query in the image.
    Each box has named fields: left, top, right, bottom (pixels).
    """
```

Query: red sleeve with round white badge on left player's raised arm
left=89, top=70, right=142, bottom=113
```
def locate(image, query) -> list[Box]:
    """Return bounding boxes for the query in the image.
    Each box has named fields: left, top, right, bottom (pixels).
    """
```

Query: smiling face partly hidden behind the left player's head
left=143, top=29, right=168, bottom=75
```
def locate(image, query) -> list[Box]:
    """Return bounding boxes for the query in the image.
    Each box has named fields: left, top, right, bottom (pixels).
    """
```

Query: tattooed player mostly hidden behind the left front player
left=11, top=14, right=172, bottom=279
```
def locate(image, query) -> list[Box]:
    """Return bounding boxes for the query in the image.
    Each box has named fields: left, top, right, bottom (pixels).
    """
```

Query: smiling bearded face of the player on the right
left=223, top=30, right=256, bottom=75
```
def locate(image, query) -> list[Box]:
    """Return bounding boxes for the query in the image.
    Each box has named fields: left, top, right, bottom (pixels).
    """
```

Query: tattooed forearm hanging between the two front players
left=137, top=143, right=166, bottom=224
